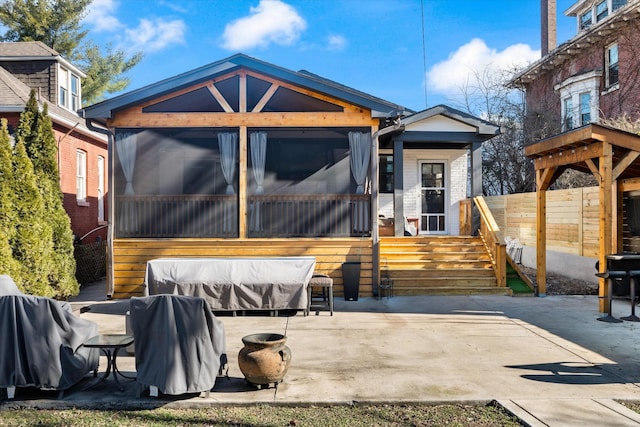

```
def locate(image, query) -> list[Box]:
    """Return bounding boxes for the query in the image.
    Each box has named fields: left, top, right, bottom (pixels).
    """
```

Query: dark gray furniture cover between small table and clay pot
left=131, top=295, right=227, bottom=395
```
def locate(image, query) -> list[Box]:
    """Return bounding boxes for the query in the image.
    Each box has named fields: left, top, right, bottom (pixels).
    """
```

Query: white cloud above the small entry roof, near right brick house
left=427, top=39, right=540, bottom=94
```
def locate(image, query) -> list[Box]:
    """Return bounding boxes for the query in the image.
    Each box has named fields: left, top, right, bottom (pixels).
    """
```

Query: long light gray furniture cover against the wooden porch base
left=145, top=256, right=316, bottom=311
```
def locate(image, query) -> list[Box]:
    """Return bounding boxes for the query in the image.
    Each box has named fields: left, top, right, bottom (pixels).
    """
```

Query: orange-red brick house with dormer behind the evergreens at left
left=0, top=42, right=108, bottom=243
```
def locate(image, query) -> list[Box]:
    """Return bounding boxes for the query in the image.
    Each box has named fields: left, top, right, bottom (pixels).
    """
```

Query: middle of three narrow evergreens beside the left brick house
left=10, top=137, right=56, bottom=297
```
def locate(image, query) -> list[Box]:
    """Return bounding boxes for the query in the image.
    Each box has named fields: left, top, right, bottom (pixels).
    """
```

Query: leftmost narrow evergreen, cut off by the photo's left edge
left=0, top=119, right=20, bottom=281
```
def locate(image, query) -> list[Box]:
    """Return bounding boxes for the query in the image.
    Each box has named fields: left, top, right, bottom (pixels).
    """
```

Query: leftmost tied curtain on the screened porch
left=116, top=132, right=138, bottom=233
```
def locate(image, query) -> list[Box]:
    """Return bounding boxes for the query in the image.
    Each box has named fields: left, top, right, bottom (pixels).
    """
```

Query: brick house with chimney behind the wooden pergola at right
left=510, top=0, right=640, bottom=140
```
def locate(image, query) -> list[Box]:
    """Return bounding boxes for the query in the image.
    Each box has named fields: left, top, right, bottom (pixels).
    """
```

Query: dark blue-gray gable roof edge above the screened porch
left=80, top=54, right=406, bottom=119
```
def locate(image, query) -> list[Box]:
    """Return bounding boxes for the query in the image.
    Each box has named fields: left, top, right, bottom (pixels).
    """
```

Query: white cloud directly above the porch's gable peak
left=222, top=0, right=307, bottom=50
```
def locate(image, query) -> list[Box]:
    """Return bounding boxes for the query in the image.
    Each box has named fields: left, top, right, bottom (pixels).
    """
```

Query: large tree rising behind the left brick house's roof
left=0, top=0, right=142, bottom=103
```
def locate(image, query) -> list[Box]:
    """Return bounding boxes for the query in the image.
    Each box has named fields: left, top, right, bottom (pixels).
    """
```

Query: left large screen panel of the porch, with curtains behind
left=113, top=128, right=239, bottom=238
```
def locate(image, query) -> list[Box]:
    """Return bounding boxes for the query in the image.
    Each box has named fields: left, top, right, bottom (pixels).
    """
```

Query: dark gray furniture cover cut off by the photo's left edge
left=0, top=275, right=99, bottom=390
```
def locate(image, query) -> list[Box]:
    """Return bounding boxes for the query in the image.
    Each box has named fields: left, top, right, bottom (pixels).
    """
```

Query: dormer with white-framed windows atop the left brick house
left=0, top=42, right=85, bottom=113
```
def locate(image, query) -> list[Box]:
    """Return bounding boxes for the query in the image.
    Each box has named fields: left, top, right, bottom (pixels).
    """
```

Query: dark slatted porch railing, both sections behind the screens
left=116, top=194, right=371, bottom=238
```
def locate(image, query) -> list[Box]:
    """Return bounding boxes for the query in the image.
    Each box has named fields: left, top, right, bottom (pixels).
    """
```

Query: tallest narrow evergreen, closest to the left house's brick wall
left=17, top=90, right=79, bottom=297
